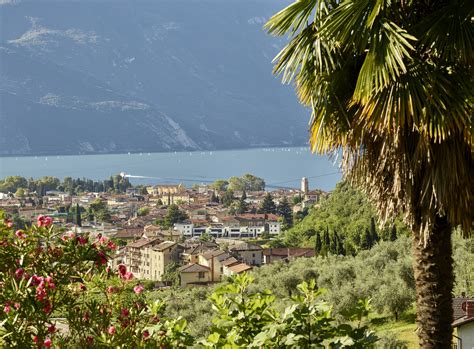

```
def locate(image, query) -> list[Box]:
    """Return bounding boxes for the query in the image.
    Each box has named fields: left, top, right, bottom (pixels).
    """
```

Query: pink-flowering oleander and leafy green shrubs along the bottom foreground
left=0, top=216, right=377, bottom=348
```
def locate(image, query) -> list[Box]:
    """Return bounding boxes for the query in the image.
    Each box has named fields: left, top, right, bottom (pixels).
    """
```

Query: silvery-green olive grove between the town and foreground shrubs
left=151, top=234, right=474, bottom=348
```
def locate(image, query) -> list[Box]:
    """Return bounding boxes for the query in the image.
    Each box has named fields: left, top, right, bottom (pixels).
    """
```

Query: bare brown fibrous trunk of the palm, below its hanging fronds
left=413, top=216, right=454, bottom=349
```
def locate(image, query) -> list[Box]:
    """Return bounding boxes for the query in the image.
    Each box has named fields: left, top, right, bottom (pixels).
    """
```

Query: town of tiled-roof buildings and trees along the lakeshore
left=0, top=174, right=328, bottom=287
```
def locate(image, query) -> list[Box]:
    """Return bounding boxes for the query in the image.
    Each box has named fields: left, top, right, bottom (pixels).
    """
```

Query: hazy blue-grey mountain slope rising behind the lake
left=0, top=0, right=308, bottom=155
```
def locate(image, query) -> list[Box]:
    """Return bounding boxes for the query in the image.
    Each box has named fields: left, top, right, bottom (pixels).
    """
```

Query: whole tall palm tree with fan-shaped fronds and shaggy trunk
left=266, top=0, right=474, bottom=348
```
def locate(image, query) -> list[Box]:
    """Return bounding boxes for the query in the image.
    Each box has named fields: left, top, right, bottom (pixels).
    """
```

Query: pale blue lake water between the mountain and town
left=0, top=147, right=341, bottom=190
